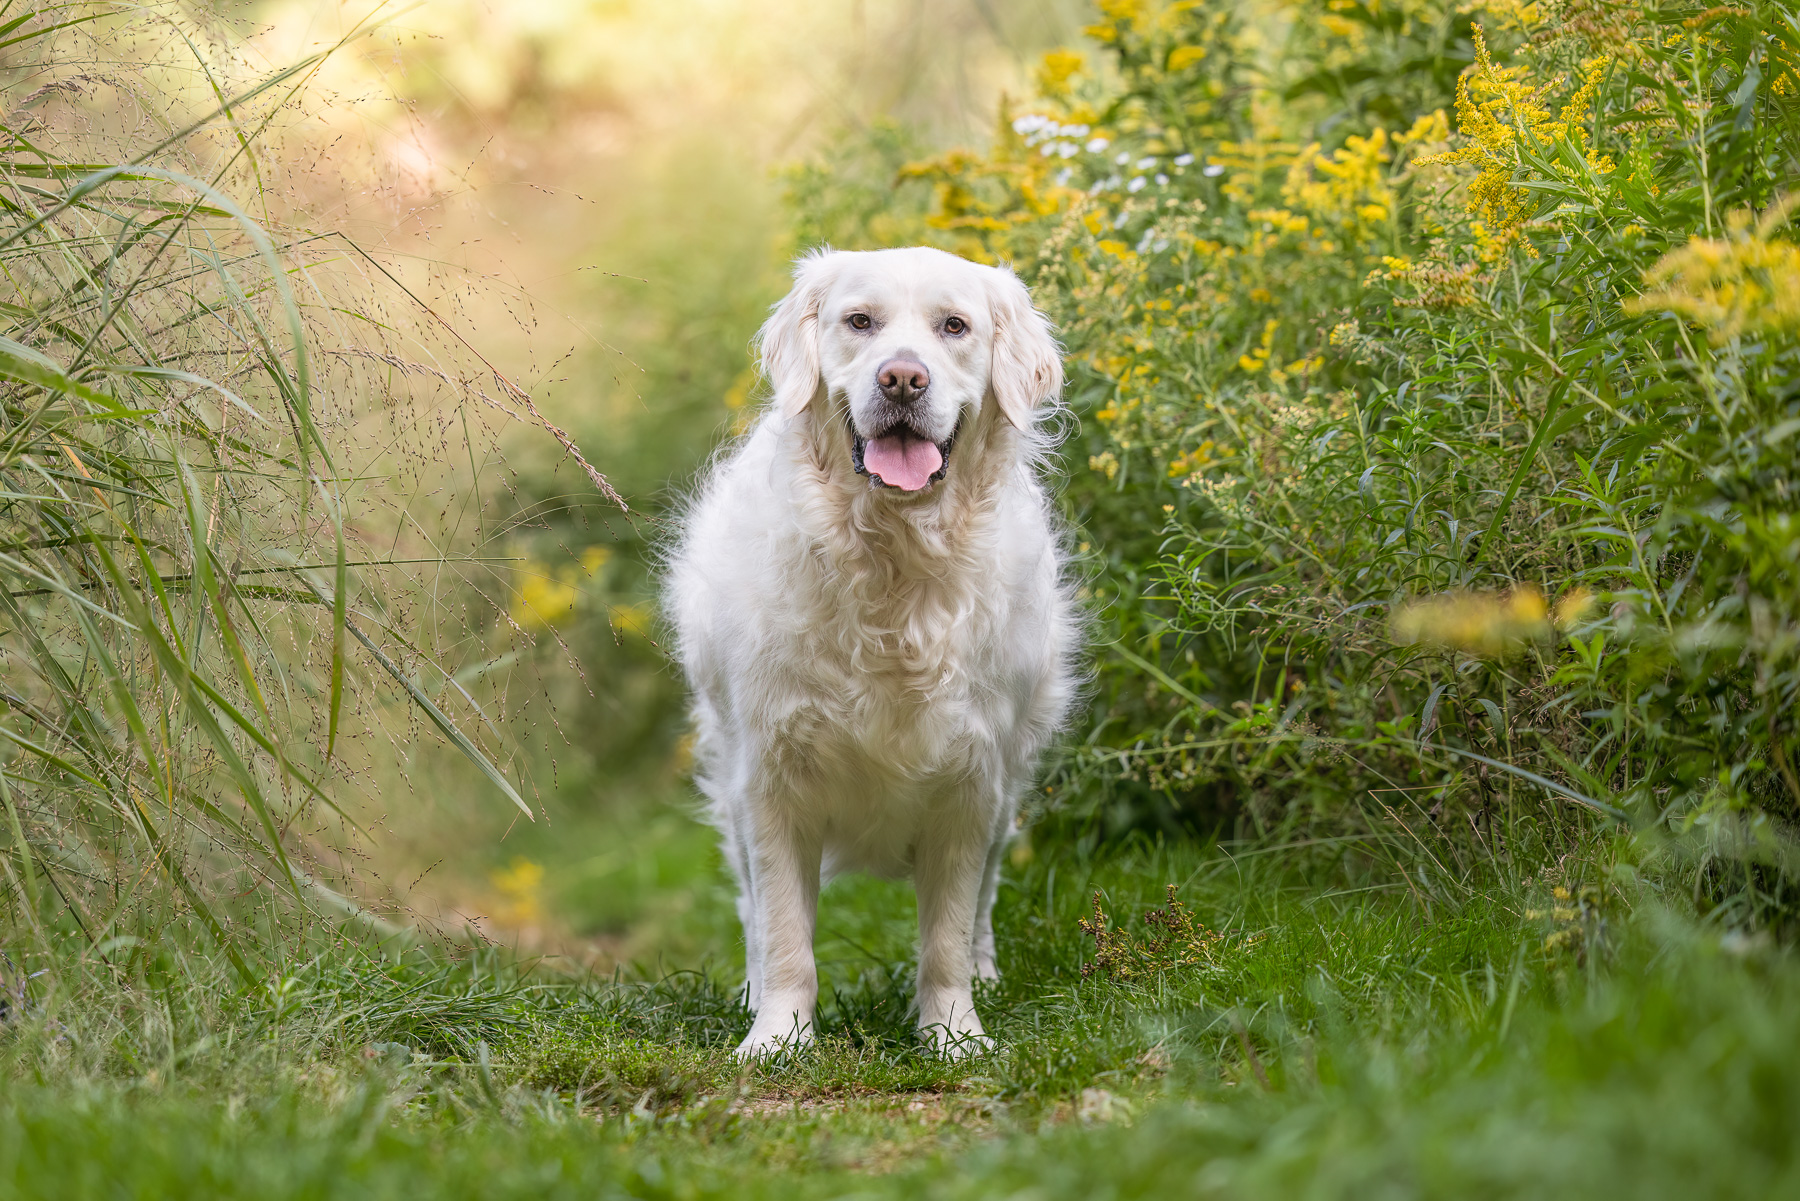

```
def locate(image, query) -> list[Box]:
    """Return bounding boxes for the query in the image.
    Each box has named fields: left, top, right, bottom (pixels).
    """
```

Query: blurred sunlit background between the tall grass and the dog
left=225, top=0, right=1082, bottom=967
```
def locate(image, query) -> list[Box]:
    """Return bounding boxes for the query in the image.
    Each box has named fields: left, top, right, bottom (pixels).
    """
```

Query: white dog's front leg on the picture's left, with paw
left=738, top=808, right=819, bottom=1057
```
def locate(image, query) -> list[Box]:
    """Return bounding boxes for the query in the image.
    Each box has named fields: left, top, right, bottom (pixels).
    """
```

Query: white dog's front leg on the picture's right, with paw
left=913, top=807, right=988, bottom=1055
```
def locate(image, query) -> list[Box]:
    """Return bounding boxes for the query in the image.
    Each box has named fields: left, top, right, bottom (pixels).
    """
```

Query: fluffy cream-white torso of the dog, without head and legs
left=671, top=414, right=1071, bottom=875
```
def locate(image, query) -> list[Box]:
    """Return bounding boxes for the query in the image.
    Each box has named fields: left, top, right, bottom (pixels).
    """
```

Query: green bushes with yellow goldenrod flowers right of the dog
left=797, top=0, right=1800, bottom=929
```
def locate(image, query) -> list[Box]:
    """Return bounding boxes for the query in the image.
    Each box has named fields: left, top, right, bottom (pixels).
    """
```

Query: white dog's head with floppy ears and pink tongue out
left=758, top=247, right=1062, bottom=493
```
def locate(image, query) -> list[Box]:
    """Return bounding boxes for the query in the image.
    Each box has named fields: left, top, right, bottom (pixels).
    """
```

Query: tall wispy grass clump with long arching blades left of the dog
left=0, top=4, right=616, bottom=983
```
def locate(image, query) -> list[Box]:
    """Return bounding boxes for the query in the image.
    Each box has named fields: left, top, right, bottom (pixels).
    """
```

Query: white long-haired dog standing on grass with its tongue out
left=666, top=248, right=1078, bottom=1055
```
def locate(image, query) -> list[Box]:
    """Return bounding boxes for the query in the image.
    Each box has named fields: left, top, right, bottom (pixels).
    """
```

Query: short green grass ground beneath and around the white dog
left=0, top=813, right=1800, bottom=1197
